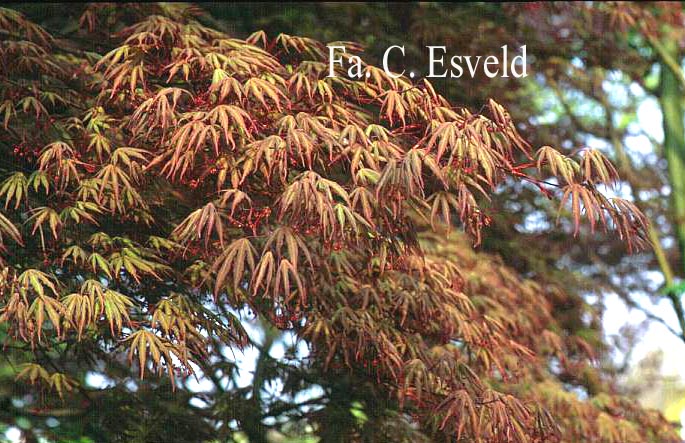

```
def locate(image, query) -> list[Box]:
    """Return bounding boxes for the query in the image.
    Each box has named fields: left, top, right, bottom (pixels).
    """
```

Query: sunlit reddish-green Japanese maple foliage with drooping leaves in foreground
left=0, top=6, right=670, bottom=442
